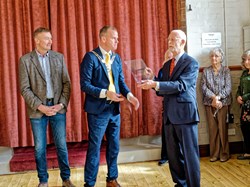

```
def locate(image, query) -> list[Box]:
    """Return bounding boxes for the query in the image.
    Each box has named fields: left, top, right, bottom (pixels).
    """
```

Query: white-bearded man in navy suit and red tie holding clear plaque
left=138, top=30, right=200, bottom=187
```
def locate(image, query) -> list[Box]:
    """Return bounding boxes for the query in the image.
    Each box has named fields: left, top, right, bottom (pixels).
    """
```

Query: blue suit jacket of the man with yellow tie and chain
left=80, top=47, right=130, bottom=114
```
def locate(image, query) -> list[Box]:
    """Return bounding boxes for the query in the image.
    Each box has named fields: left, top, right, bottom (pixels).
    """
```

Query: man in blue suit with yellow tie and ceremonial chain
left=80, top=26, right=139, bottom=187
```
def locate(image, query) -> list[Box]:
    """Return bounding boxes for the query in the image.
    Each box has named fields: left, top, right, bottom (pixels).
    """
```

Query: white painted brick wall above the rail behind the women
left=186, top=0, right=250, bottom=67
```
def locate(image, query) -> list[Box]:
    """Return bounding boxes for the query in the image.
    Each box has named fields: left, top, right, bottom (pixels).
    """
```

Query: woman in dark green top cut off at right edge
left=236, top=49, right=250, bottom=160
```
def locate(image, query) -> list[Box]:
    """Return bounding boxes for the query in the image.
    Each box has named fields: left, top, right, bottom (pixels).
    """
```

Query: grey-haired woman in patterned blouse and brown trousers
left=201, top=48, right=231, bottom=162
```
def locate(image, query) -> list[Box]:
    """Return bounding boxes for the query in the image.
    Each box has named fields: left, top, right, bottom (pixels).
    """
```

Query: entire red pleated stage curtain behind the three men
left=0, top=0, right=177, bottom=147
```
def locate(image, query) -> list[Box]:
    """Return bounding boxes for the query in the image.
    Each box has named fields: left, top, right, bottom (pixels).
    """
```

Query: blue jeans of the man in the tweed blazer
left=30, top=103, right=70, bottom=182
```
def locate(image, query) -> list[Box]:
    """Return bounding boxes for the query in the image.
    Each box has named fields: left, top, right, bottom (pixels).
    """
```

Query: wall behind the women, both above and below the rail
left=186, top=0, right=250, bottom=145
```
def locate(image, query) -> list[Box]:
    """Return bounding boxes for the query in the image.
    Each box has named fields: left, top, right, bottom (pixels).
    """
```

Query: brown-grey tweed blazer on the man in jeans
left=19, top=50, right=71, bottom=118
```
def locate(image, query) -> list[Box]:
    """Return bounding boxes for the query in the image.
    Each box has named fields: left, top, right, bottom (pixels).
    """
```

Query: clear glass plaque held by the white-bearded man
left=124, top=59, right=149, bottom=83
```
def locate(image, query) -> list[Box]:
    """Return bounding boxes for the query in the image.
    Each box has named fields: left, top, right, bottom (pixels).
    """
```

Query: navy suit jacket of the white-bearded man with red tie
left=158, top=53, right=199, bottom=124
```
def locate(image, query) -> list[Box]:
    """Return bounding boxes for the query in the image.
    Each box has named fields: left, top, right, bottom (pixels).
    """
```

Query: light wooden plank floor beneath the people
left=0, top=155, right=250, bottom=187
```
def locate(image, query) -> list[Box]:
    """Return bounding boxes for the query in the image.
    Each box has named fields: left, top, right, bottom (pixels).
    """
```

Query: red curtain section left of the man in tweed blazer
left=0, top=0, right=49, bottom=147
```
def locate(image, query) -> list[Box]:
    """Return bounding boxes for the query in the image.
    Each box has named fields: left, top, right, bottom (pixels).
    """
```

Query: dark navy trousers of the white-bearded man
left=164, top=121, right=200, bottom=187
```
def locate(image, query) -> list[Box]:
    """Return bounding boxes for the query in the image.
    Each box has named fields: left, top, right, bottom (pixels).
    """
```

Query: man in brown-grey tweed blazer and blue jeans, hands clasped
left=19, top=27, right=74, bottom=187
